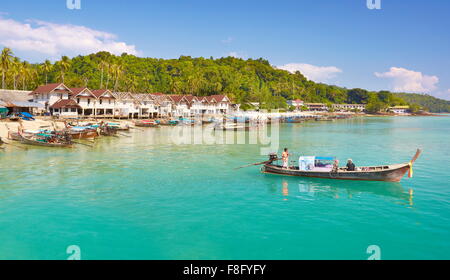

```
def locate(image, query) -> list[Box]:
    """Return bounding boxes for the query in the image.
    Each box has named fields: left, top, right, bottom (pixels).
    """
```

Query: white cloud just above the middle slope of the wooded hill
left=277, top=63, right=342, bottom=83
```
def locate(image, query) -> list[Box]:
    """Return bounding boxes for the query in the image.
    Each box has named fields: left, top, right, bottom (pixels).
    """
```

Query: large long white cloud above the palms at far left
left=0, top=17, right=138, bottom=58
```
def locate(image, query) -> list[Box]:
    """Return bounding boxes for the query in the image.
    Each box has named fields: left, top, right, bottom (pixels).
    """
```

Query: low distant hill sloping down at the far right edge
left=395, top=93, right=450, bottom=113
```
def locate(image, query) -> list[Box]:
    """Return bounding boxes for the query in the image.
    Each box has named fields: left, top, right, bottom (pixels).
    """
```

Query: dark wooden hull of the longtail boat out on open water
left=261, top=163, right=411, bottom=182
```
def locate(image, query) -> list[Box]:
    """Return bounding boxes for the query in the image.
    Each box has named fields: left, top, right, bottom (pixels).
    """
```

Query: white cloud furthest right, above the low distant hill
left=375, top=67, right=439, bottom=93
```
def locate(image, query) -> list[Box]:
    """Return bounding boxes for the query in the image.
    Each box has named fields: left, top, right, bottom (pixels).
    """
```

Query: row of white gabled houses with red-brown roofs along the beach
left=30, top=83, right=239, bottom=118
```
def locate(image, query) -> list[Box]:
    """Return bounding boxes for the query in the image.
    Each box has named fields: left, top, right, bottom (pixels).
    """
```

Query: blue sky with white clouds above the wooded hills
left=0, top=0, right=450, bottom=100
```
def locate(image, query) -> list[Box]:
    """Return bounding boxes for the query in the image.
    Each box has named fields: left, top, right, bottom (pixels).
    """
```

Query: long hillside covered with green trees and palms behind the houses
left=0, top=48, right=450, bottom=112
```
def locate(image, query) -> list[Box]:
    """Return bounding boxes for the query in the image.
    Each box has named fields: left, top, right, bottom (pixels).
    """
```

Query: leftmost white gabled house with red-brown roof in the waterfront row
left=29, top=83, right=72, bottom=111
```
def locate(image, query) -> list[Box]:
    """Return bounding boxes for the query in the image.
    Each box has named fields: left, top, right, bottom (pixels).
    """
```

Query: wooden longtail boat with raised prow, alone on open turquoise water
left=261, top=149, right=422, bottom=182
